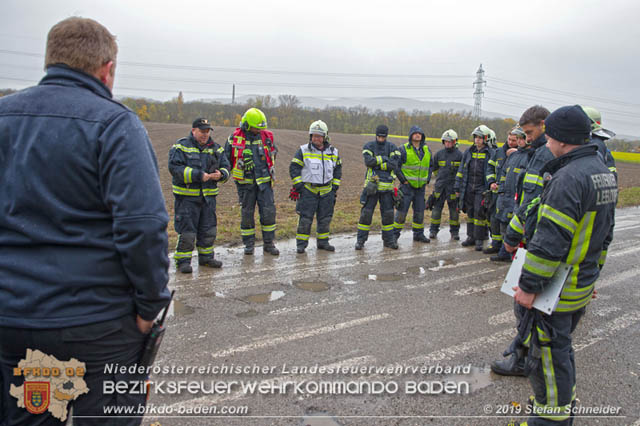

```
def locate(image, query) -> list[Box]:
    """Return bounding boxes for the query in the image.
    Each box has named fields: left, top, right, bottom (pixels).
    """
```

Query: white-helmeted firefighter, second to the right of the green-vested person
left=454, top=124, right=493, bottom=251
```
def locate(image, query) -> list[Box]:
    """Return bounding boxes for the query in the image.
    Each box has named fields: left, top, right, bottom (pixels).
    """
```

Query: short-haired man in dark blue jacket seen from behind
left=0, top=17, right=169, bottom=425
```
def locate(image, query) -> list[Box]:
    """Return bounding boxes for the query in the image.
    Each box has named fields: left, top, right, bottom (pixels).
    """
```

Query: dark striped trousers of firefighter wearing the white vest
left=296, top=188, right=336, bottom=248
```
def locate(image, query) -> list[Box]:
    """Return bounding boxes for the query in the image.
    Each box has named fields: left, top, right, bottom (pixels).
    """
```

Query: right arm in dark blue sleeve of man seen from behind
left=98, top=111, right=169, bottom=321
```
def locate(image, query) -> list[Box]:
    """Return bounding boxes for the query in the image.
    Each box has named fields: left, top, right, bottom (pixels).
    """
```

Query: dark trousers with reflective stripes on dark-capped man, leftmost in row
left=173, top=195, right=218, bottom=265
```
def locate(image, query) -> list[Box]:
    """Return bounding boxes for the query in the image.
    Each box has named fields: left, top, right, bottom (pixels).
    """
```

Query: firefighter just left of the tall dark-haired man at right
left=485, top=126, right=535, bottom=262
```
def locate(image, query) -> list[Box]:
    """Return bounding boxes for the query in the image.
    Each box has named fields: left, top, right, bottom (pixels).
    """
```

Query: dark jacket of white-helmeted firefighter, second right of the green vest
left=454, top=145, right=493, bottom=208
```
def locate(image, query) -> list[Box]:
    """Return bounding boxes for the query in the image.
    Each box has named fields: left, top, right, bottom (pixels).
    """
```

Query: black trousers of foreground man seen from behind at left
left=0, top=315, right=147, bottom=426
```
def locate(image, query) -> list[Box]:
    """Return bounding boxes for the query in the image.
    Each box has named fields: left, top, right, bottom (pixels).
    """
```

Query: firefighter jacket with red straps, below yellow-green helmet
left=224, top=128, right=278, bottom=186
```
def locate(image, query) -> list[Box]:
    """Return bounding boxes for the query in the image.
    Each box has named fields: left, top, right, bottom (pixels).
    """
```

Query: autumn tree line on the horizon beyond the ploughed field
left=0, top=89, right=640, bottom=152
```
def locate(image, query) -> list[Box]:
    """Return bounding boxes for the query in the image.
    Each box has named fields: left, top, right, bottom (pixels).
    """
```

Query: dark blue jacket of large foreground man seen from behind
left=0, top=66, right=169, bottom=329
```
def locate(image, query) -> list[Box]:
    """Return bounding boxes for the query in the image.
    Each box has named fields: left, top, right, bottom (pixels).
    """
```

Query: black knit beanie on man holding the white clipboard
left=544, top=105, right=591, bottom=145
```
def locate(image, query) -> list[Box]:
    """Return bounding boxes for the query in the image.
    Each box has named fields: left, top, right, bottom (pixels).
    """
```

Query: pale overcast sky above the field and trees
left=0, top=0, right=640, bottom=136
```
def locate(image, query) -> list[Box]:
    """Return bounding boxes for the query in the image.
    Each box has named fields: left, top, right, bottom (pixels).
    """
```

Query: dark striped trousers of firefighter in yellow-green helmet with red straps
left=237, top=183, right=276, bottom=247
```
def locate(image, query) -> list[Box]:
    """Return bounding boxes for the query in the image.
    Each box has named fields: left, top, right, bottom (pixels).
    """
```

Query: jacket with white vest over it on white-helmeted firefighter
left=289, top=142, right=342, bottom=195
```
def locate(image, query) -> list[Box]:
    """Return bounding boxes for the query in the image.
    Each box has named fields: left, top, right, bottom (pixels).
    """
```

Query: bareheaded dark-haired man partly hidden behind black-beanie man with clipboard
left=491, top=105, right=553, bottom=376
